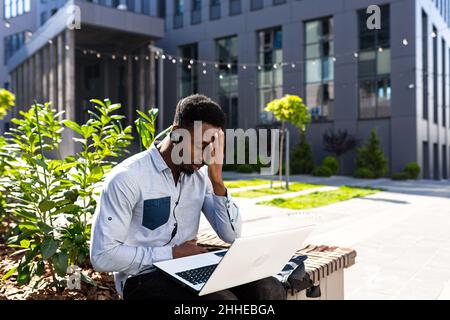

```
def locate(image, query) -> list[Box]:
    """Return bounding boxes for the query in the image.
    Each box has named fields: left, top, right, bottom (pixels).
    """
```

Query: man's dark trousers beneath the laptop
left=123, top=271, right=286, bottom=301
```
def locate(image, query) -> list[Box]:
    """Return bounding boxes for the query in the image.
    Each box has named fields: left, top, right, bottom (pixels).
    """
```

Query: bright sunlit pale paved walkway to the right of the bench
left=201, top=176, right=450, bottom=299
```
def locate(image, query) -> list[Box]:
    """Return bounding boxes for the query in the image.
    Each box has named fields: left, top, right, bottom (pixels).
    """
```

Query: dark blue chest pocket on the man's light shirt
left=142, top=197, right=170, bottom=231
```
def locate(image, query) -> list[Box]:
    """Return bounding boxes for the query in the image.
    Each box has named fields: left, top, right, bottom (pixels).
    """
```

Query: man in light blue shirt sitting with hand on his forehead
left=91, top=95, right=286, bottom=300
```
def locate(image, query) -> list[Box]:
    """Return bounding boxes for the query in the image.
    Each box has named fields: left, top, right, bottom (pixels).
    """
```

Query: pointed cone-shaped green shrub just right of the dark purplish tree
left=356, top=129, right=388, bottom=179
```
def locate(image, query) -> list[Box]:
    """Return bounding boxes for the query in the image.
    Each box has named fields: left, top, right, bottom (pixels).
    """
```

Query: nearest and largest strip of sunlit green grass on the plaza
left=258, top=186, right=381, bottom=210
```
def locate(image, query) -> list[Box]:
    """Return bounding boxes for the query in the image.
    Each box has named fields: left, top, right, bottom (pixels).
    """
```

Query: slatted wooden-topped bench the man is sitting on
left=197, top=233, right=356, bottom=300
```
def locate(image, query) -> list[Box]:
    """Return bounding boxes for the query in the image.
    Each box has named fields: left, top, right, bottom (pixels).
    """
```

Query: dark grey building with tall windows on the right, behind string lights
left=158, top=0, right=450, bottom=179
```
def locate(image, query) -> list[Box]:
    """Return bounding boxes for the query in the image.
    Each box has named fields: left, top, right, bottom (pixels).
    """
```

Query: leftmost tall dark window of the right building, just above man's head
left=178, top=44, right=198, bottom=98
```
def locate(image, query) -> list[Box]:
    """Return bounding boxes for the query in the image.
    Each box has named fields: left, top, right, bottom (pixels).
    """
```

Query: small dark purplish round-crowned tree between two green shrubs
left=323, top=129, right=358, bottom=174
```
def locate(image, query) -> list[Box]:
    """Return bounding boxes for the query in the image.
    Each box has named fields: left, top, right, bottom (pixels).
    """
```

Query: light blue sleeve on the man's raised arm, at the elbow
left=202, top=178, right=242, bottom=243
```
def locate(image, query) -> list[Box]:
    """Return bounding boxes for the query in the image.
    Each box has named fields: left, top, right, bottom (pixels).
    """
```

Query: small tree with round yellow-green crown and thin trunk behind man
left=265, top=95, right=311, bottom=184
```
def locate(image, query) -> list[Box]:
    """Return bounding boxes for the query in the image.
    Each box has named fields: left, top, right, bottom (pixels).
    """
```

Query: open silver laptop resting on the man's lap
left=154, top=225, right=314, bottom=296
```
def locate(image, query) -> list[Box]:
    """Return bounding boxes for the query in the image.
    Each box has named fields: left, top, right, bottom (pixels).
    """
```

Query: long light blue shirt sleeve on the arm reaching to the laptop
left=91, top=171, right=173, bottom=275
